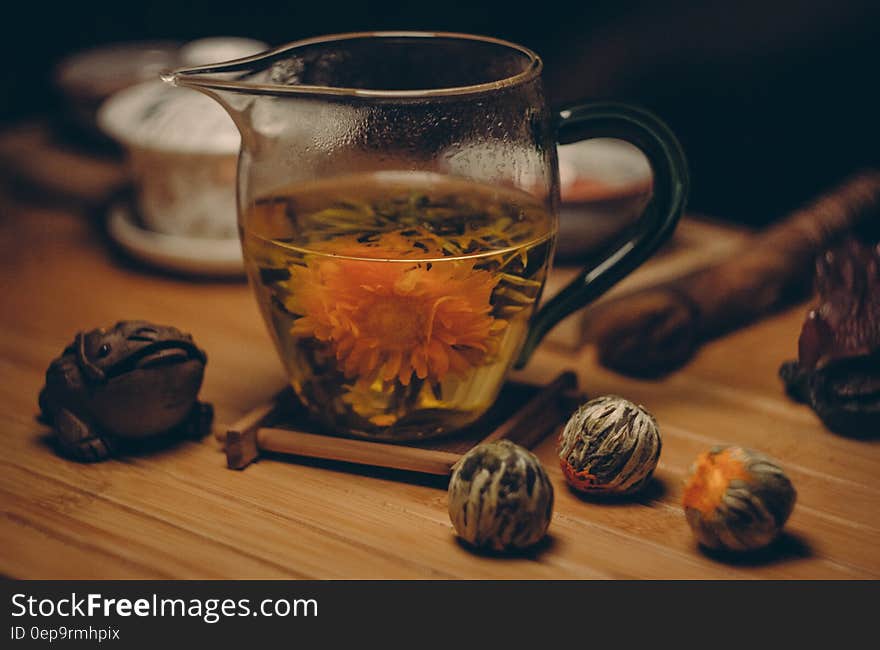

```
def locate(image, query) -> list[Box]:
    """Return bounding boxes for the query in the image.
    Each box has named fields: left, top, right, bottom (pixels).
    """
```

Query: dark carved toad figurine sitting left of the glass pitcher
left=40, top=321, right=214, bottom=462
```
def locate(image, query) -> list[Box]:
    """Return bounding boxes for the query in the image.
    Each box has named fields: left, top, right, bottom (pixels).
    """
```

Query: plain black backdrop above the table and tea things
left=0, top=0, right=880, bottom=224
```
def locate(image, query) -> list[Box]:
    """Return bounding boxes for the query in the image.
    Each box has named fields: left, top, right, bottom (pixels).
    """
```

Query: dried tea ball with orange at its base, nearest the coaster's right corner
left=559, top=395, right=662, bottom=494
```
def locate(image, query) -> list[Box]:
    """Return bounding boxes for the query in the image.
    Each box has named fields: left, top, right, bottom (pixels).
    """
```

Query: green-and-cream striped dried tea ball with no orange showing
left=449, top=440, right=553, bottom=551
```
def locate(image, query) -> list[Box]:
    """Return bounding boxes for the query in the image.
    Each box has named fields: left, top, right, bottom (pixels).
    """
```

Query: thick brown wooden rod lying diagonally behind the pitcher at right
left=592, top=170, right=880, bottom=377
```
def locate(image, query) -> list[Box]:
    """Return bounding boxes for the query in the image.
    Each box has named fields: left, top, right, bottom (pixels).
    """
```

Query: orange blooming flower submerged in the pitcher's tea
left=285, top=237, right=507, bottom=386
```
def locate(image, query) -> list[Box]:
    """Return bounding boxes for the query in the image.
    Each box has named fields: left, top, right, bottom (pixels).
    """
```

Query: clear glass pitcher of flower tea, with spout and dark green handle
left=164, top=32, right=687, bottom=440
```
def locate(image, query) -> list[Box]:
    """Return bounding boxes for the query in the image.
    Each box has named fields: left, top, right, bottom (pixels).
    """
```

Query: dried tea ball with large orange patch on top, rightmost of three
left=683, top=446, right=797, bottom=551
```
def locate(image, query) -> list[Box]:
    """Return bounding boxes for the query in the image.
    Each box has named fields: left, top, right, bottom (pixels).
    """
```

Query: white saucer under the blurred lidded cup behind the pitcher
left=107, top=202, right=244, bottom=278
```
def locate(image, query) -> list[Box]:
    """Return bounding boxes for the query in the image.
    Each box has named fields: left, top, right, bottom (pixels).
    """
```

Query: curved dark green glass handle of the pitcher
left=515, top=103, right=688, bottom=368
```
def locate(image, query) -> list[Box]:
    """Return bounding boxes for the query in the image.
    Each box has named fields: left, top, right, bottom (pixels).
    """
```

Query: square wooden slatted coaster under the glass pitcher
left=216, top=371, right=582, bottom=476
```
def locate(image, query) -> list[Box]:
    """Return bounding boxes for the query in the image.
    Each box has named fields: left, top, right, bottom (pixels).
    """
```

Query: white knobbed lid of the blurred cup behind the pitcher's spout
left=98, top=38, right=268, bottom=154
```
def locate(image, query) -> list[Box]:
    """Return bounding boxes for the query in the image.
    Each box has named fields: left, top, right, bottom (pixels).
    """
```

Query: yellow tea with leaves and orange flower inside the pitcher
left=242, top=172, right=555, bottom=439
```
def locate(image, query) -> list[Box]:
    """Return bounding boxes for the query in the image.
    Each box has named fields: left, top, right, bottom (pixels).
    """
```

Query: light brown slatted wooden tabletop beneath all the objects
left=0, top=167, right=880, bottom=578
